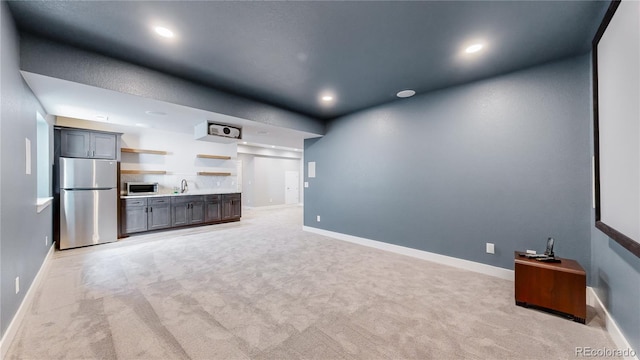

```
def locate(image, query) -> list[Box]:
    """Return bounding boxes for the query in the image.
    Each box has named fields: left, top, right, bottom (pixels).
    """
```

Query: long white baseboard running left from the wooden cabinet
left=302, top=226, right=514, bottom=281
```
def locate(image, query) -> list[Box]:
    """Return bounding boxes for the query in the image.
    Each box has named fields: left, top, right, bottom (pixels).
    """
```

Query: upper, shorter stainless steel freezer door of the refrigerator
left=60, top=158, right=117, bottom=189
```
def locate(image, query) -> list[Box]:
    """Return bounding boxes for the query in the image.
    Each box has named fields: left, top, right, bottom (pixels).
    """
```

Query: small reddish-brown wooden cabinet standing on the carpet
left=515, top=251, right=587, bottom=324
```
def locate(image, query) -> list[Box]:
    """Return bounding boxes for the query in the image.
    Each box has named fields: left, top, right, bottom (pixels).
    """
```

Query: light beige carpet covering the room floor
left=8, top=207, right=615, bottom=359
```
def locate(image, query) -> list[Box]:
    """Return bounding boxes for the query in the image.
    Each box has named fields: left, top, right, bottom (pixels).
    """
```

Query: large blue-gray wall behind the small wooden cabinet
left=304, top=55, right=591, bottom=275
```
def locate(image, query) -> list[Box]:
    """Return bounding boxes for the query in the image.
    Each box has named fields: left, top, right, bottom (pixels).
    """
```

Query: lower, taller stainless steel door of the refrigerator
left=60, top=189, right=118, bottom=249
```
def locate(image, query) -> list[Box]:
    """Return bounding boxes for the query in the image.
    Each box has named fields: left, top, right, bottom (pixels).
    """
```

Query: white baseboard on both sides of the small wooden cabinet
left=302, top=226, right=640, bottom=360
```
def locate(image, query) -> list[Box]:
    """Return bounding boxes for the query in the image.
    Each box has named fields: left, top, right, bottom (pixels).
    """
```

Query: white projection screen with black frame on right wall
left=593, top=0, right=640, bottom=257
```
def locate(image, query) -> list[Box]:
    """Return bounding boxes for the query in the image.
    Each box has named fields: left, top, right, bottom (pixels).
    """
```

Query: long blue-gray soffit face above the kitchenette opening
left=20, top=33, right=324, bottom=135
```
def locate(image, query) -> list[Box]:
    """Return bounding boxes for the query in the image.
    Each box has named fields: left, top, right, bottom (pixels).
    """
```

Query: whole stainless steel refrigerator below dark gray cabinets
left=59, top=157, right=118, bottom=249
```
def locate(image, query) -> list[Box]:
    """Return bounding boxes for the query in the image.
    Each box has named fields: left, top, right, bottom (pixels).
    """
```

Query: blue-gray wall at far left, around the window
left=0, top=1, right=52, bottom=338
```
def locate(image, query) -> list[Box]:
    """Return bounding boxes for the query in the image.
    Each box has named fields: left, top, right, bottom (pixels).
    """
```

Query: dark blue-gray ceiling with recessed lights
left=8, top=1, right=608, bottom=119
